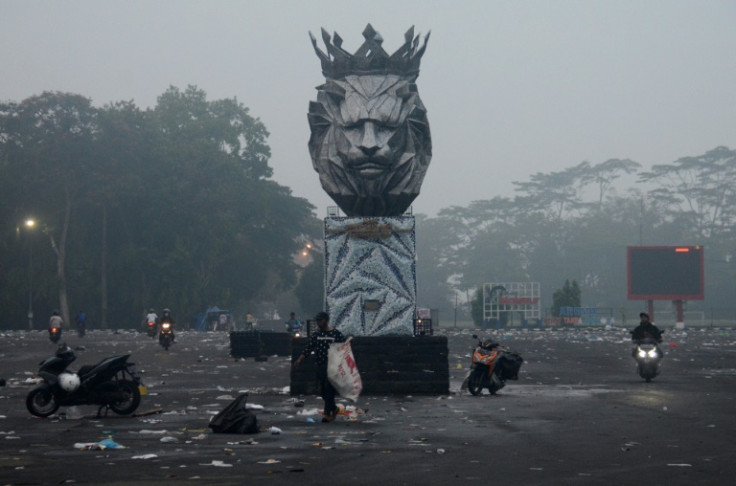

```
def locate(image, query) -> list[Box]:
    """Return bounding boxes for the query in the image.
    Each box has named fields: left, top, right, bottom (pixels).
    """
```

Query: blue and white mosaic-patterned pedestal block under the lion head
left=325, top=216, right=417, bottom=336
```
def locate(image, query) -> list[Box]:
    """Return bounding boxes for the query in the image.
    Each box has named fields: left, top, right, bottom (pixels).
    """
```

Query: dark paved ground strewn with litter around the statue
left=0, top=329, right=736, bottom=486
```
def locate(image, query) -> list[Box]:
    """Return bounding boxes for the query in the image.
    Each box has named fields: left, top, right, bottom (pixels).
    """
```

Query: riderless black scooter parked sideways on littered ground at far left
left=26, top=344, right=143, bottom=417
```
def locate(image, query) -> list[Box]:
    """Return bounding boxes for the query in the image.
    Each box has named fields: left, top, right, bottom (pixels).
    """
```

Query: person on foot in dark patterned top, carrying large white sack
left=293, top=312, right=345, bottom=422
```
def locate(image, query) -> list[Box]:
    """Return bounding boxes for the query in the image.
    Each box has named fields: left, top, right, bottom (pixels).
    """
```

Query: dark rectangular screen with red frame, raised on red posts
left=626, top=246, right=705, bottom=300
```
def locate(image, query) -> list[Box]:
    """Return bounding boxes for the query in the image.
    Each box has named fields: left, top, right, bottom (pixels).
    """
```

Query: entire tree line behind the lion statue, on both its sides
left=0, top=86, right=736, bottom=328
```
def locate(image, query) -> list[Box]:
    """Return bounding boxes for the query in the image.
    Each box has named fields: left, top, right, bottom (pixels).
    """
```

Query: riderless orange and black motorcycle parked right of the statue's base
left=466, top=334, right=524, bottom=395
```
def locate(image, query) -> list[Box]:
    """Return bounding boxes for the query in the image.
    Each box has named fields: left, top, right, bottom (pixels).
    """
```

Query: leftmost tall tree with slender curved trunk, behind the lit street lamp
left=0, top=92, right=97, bottom=323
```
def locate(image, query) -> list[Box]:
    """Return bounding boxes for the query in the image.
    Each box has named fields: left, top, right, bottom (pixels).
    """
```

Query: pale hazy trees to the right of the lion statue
left=417, top=146, right=736, bottom=320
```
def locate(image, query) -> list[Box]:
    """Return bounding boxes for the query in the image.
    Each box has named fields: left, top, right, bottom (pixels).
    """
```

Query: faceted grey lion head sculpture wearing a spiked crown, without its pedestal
left=308, top=24, right=432, bottom=216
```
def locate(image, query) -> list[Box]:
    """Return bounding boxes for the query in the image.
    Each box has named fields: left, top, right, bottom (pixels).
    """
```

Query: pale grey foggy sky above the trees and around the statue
left=0, top=0, right=736, bottom=218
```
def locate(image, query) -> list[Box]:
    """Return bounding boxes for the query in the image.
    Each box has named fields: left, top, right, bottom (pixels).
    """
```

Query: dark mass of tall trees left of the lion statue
left=0, top=86, right=321, bottom=327
